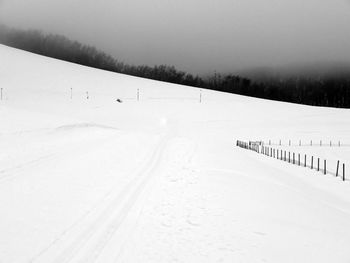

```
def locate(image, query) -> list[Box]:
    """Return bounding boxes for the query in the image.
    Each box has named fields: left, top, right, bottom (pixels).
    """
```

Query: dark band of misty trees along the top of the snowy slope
left=0, top=25, right=350, bottom=108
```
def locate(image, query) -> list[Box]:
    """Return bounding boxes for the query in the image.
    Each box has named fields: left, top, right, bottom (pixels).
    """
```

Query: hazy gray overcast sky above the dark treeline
left=0, top=0, right=350, bottom=73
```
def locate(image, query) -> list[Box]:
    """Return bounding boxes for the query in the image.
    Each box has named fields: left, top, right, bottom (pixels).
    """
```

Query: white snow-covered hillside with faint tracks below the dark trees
left=0, top=46, right=350, bottom=263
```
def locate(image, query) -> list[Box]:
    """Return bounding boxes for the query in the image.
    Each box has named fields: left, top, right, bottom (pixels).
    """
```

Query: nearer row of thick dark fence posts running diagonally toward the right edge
left=236, top=140, right=345, bottom=181
